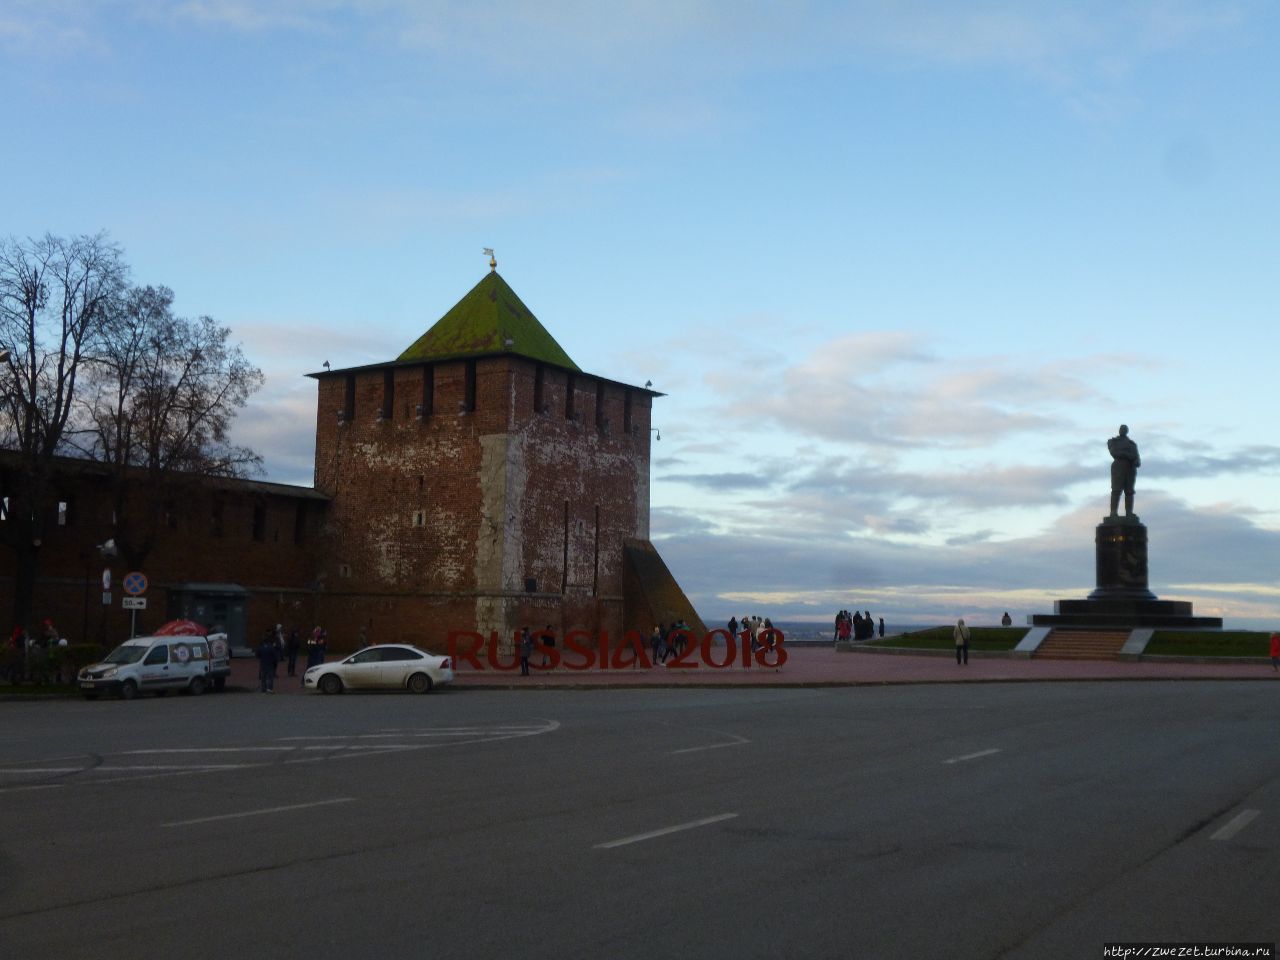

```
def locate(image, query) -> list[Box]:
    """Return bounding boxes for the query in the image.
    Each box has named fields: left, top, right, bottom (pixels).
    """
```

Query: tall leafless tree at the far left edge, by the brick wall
left=0, top=234, right=127, bottom=632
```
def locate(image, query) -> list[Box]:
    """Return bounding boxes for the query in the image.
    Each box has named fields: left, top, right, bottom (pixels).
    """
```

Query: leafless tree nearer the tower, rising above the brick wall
left=72, top=287, right=262, bottom=568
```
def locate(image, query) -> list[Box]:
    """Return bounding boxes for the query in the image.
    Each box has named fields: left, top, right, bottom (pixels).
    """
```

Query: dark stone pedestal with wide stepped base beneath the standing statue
left=1032, top=516, right=1222, bottom=630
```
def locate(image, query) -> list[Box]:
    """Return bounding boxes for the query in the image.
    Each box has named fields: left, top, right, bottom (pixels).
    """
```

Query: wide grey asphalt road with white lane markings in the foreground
left=0, top=682, right=1280, bottom=959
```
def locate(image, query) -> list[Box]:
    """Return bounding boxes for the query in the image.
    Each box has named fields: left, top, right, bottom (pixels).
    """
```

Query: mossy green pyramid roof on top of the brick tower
left=397, top=271, right=579, bottom=370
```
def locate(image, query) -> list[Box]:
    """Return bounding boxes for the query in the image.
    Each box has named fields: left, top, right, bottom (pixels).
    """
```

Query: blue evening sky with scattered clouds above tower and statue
left=0, top=0, right=1280, bottom=628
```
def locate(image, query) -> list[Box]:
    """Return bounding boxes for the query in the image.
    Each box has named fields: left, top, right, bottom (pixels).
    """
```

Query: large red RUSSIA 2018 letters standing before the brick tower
left=448, top=630, right=787, bottom=671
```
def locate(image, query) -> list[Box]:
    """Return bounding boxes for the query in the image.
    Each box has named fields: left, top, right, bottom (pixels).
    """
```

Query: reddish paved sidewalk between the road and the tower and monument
left=229, top=646, right=1280, bottom=694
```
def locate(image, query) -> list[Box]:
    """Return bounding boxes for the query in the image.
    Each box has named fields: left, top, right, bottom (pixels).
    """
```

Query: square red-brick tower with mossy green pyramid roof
left=311, top=269, right=703, bottom=649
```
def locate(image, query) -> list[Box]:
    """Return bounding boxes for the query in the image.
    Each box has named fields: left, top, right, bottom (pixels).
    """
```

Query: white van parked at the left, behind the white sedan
left=77, top=636, right=211, bottom=700
